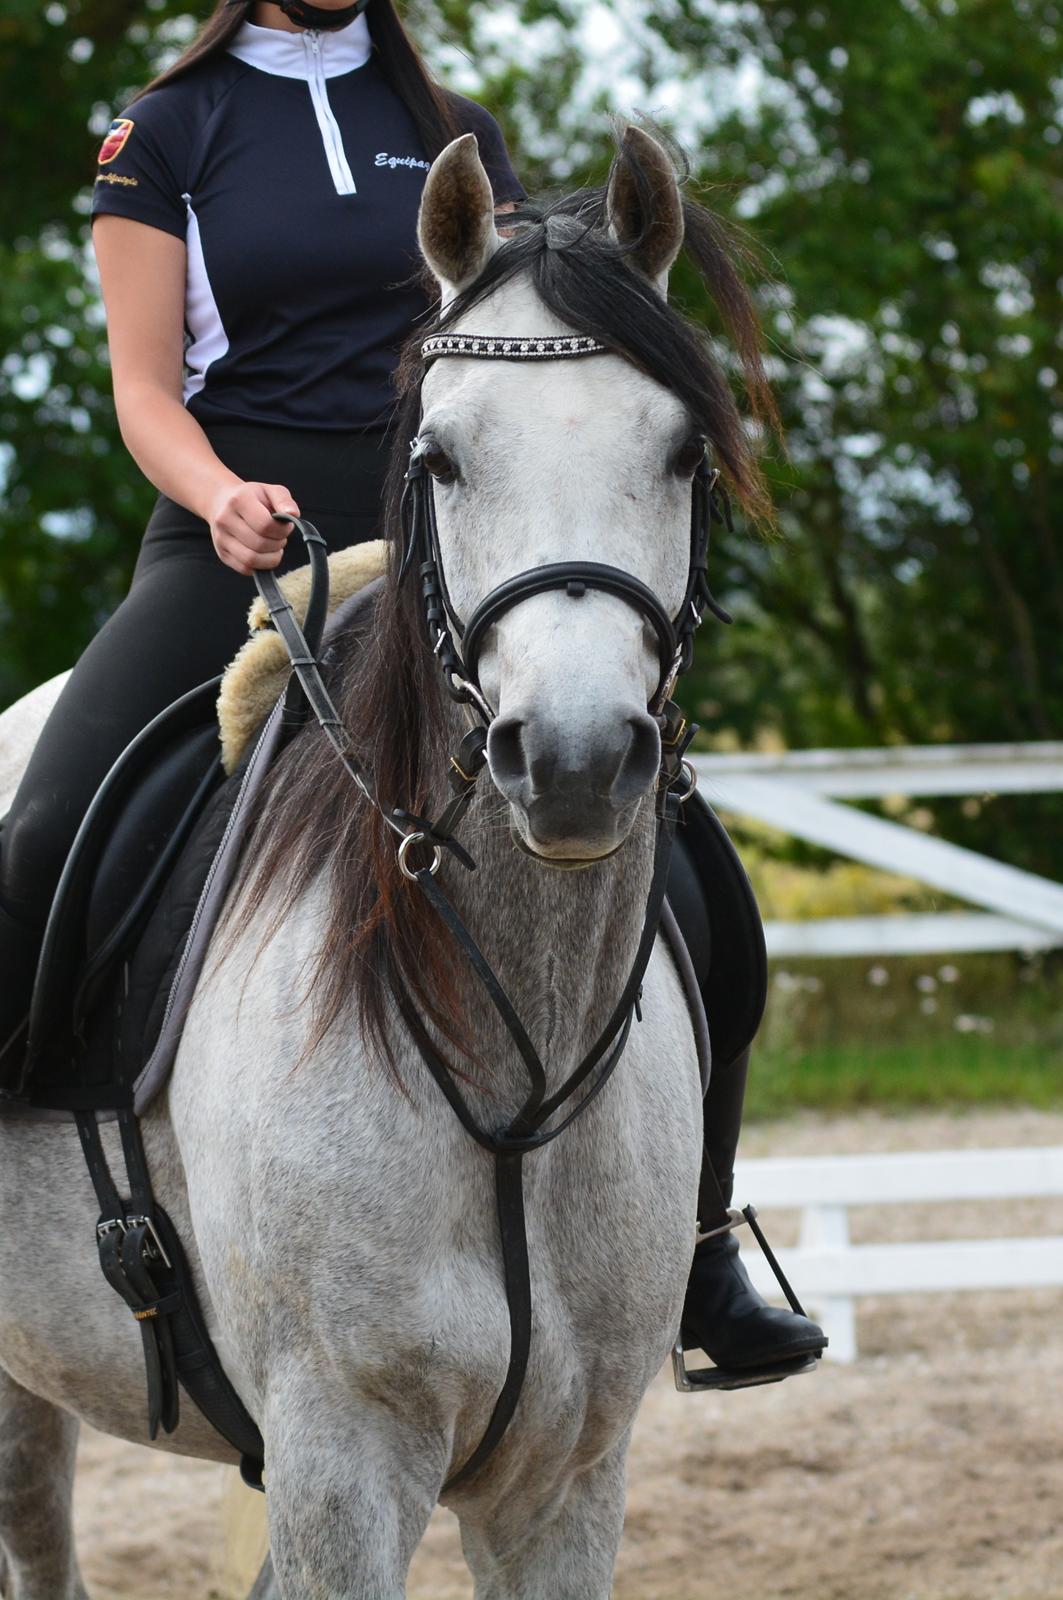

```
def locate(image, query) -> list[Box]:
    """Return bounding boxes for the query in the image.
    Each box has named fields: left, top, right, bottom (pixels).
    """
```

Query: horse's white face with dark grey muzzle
left=418, top=136, right=692, bottom=861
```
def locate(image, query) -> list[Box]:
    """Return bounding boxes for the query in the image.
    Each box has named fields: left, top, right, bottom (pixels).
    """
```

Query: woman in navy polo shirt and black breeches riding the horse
left=0, top=0, right=826, bottom=1368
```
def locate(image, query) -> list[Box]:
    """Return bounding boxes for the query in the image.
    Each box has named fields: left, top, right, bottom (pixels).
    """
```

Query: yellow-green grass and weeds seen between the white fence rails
left=701, top=818, right=1063, bottom=1118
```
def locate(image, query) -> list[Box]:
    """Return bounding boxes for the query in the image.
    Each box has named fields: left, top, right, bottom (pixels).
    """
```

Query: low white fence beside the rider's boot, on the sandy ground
left=735, top=1146, right=1063, bottom=1362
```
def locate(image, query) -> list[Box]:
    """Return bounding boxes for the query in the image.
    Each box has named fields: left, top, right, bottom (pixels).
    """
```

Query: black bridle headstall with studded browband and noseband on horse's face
left=399, top=333, right=732, bottom=723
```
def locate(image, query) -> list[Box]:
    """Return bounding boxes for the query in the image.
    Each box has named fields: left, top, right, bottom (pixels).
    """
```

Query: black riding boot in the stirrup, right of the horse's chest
left=680, top=1050, right=828, bottom=1373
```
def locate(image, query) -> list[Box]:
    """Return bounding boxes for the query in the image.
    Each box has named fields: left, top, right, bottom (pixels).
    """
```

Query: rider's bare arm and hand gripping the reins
left=93, top=213, right=299, bottom=573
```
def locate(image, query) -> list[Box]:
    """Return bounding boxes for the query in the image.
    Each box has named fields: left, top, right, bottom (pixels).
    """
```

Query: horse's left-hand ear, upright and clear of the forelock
left=418, top=133, right=501, bottom=304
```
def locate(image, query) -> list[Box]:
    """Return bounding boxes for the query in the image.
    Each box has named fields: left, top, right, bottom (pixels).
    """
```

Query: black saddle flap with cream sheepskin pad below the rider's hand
left=12, top=541, right=386, bottom=1115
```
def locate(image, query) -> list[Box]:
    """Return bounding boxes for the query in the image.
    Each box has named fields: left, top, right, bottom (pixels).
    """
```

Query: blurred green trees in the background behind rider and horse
left=0, top=0, right=1063, bottom=877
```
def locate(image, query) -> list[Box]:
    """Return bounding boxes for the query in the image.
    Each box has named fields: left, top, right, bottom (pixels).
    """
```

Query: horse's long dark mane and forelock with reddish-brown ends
left=227, top=124, right=778, bottom=1061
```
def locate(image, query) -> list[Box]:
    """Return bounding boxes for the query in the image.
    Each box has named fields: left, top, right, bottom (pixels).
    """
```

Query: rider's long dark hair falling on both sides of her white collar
left=130, top=0, right=463, bottom=162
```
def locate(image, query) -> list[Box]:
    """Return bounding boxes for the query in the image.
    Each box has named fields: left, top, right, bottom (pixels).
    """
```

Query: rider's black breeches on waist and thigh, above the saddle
left=0, top=422, right=389, bottom=931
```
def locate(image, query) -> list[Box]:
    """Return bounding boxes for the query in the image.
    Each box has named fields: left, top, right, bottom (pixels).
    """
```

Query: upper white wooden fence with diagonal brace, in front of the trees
left=693, top=742, right=1063, bottom=955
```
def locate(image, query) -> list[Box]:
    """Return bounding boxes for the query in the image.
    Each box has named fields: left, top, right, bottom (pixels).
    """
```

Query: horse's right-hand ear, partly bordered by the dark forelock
left=605, top=123, right=684, bottom=296
